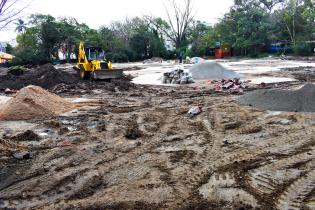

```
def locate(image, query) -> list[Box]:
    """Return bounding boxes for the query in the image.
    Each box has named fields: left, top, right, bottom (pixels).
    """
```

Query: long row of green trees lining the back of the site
left=7, top=0, right=315, bottom=65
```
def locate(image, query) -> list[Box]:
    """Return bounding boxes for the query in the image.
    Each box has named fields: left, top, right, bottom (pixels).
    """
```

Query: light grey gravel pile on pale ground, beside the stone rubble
left=189, top=62, right=241, bottom=80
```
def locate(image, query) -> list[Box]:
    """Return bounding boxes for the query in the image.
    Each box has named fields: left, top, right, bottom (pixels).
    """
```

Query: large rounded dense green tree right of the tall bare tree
left=216, top=2, right=270, bottom=55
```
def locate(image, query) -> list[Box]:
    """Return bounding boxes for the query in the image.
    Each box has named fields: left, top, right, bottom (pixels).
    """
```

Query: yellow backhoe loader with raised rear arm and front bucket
left=77, top=41, right=123, bottom=80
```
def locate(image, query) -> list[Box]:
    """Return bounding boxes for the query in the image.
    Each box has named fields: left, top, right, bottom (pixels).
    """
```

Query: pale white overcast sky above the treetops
left=0, top=0, right=233, bottom=41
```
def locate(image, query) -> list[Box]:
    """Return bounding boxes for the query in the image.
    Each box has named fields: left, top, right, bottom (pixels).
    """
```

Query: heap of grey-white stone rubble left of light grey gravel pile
left=162, top=69, right=194, bottom=84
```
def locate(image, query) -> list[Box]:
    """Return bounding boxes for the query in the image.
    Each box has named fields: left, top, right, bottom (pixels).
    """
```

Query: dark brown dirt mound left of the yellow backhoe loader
left=0, top=64, right=80, bottom=89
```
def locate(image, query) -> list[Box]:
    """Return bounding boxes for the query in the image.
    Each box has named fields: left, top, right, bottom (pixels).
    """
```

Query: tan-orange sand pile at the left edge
left=0, top=86, right=74, bottom=120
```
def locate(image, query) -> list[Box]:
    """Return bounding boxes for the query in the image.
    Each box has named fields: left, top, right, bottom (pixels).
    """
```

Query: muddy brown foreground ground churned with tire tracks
left=0, top=57, right=315, bottom=210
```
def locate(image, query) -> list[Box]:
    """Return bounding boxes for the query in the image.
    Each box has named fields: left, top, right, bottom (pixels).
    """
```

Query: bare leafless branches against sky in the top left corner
left=0, top=0, right=30, bottom=30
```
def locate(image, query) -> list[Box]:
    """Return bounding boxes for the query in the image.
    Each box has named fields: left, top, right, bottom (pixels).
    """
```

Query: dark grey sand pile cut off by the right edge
left=238, top=84, right=315, bottom=112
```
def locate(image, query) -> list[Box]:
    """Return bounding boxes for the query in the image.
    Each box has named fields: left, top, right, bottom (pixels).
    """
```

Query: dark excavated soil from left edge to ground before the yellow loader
left=0, top=64, right=134, bottom=94
